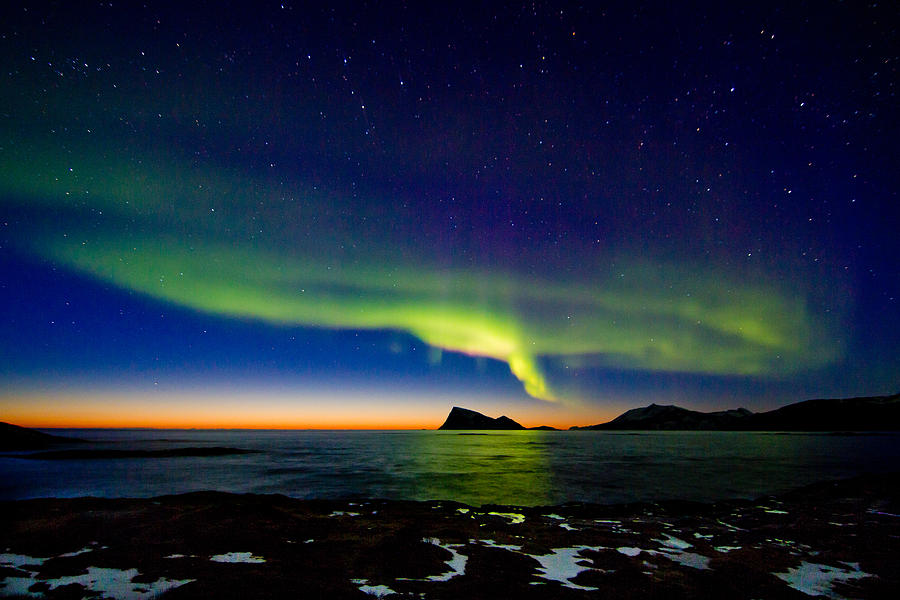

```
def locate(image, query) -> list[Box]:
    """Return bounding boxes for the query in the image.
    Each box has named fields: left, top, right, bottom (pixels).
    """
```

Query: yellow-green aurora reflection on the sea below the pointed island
left=409, top=431, right=559, bottom=506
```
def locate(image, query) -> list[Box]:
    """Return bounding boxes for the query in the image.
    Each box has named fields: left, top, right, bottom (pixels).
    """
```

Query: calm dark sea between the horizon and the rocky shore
left=0, top=429, right=900, bottom=506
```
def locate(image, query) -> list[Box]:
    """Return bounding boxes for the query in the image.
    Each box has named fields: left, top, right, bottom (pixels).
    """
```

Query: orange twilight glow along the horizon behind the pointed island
left=0, top=392, right=618, bottom=429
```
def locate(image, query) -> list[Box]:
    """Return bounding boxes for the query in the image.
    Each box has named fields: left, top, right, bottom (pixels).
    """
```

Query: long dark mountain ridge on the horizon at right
left=570, top=394, right=900, bottom=431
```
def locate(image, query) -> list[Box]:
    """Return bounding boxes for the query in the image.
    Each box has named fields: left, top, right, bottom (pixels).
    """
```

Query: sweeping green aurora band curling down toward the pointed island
left=0, top=146, right=840, bottom=400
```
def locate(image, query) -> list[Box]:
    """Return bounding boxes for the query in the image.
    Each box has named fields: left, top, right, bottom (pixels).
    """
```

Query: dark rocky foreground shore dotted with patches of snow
left=0, top=474, right=900, bottom=600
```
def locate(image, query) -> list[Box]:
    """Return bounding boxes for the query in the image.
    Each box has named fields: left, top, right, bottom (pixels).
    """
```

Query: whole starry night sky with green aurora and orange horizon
left=0, top=2, right=900, bottom=428
